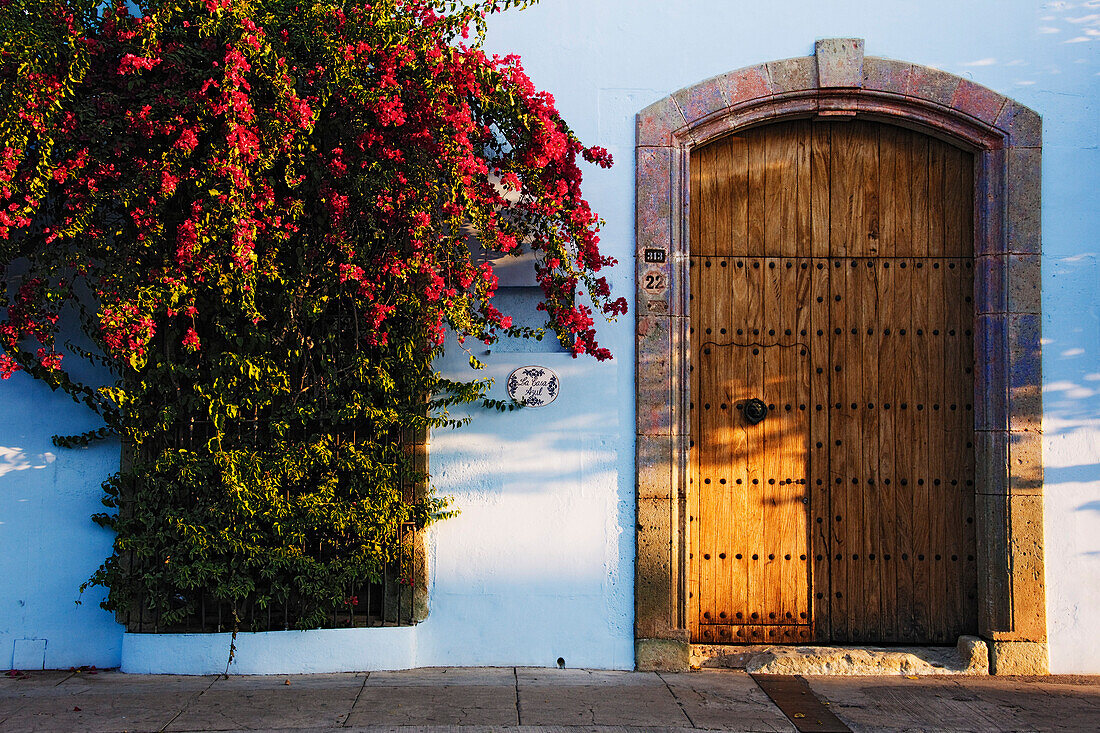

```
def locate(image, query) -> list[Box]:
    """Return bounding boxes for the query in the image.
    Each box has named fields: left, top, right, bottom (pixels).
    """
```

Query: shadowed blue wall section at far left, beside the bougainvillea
left=0, top=374, right=121, bottom=669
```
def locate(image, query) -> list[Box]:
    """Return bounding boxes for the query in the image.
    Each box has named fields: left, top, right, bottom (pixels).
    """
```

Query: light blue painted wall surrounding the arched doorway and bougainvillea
left=0, top=0, right=1100, bottom=672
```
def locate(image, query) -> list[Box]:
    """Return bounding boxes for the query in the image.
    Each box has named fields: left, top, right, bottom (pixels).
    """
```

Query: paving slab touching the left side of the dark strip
left=660, top=669, right=795, bottom=731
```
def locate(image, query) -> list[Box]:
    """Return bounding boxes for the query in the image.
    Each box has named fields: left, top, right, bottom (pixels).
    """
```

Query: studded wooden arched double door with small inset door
left=689, top=120, right=977, bottom=644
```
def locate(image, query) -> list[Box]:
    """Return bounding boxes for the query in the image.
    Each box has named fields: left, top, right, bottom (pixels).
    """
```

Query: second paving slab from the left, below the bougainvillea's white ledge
left=166, top=674, right=366, bottom=731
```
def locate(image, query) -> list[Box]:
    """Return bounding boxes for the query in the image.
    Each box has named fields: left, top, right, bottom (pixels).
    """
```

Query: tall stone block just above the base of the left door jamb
left=634, top=499, right=673, bottom=638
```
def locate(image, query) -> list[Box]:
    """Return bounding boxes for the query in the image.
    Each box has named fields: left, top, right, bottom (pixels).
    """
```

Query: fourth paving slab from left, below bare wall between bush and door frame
left=516, top=669, right=691, bottom=726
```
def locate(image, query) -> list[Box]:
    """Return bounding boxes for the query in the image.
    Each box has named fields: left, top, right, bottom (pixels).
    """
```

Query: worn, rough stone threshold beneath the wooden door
left=691, top=636, right=989, bottom=676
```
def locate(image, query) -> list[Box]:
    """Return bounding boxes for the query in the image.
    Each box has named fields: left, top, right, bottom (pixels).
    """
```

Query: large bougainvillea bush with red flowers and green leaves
left=0, top=0, right=625, bottom=627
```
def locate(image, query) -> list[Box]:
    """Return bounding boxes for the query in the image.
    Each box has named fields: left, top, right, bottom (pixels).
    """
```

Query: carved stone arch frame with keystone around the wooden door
left=635, top=39, right=1047, bottom=674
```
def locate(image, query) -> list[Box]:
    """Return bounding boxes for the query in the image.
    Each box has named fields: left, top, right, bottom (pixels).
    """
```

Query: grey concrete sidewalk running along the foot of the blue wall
left=0, top=667, right=1100, bottom=733
